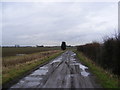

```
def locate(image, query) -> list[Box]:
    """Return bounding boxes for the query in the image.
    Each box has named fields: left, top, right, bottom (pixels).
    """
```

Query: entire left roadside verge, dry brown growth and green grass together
left=2, top=50, right=62, bottom=86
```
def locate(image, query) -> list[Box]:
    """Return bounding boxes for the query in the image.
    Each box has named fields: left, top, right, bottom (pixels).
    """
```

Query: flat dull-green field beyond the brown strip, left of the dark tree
left=2, top=47, right=60, bottom=57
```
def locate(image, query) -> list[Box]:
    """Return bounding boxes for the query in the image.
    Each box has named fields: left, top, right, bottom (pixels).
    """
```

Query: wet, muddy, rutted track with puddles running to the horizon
left=11, top=51, right=100, bottom=88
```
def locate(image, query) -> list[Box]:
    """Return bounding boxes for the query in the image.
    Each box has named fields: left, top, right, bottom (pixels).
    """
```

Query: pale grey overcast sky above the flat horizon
left=0, top=2, right=118, bottom=45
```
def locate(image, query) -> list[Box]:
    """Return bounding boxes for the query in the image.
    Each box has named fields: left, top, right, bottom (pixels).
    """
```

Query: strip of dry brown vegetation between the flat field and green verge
left=2, top=50, right=58, bottom=67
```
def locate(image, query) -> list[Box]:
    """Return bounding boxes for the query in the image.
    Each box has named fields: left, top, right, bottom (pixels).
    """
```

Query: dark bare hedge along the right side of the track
left=77, top=34, right=120, bottom=75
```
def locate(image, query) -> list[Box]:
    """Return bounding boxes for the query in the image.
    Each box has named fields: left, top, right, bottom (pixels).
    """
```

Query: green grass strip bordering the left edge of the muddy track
left=2, top=51, right=63, bottom=86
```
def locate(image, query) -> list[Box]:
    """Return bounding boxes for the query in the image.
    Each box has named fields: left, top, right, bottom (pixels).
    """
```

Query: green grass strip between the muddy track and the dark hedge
left=74, top=51, right=120, bottom=88
